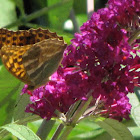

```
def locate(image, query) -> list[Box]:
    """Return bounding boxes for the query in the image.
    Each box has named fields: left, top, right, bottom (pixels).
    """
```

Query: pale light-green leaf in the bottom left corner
left=1, top=124, right=40, bottom=140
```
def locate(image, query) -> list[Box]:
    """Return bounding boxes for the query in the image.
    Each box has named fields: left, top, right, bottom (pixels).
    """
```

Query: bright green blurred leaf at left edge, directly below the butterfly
left=0, top=66, right=22, bottom=125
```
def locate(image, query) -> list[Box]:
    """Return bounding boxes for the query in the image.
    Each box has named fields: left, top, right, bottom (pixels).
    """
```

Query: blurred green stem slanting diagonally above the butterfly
left=2, top=0, right=70, bottom=28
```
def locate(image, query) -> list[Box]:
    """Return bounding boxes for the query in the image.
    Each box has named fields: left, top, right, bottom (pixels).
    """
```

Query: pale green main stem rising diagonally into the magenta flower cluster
left=59, top=90, right=92, bottom=140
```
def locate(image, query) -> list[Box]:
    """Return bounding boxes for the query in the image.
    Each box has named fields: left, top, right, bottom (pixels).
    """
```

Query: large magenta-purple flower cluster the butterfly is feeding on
left=23, top=0, right=140, bottom=120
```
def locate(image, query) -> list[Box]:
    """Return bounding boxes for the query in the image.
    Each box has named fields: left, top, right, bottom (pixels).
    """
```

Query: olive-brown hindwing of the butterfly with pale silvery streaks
left=23, top=38, right=66, bottom=88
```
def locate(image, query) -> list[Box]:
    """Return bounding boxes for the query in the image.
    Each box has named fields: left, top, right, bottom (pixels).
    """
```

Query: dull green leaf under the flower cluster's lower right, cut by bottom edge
left=96, top=118, right=134, bottom=140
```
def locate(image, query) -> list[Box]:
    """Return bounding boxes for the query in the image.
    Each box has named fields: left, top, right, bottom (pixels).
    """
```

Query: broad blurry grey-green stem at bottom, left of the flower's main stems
left=36, top=119, right=55, bottom=140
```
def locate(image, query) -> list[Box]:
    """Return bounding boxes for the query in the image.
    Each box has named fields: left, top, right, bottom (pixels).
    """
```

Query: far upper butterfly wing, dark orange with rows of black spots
left=0, top=28, right=63, bottom=49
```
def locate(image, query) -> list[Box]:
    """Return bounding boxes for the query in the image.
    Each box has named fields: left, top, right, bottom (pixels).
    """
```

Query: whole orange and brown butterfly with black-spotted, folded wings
left=0, top=28, right=67, bottom=90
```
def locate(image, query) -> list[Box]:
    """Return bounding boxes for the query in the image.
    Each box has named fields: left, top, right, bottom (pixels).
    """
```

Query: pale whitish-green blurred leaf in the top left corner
left=0, top=0, right=17, bottom=29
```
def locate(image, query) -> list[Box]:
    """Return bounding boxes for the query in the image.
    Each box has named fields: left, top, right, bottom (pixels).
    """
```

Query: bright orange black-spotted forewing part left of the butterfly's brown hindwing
left=1, top=45, right=31, bottom=84
